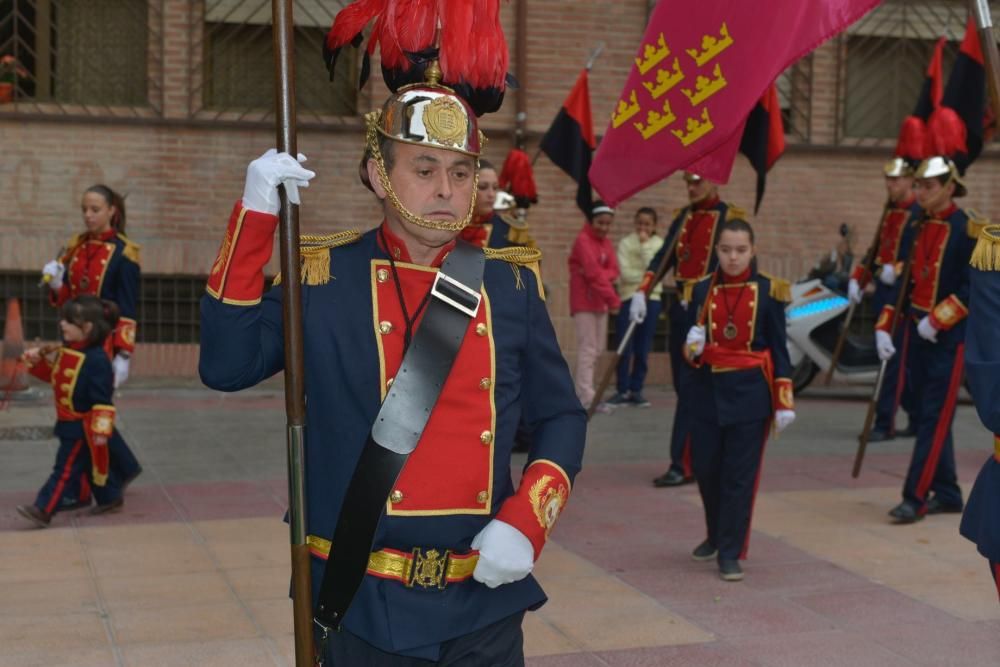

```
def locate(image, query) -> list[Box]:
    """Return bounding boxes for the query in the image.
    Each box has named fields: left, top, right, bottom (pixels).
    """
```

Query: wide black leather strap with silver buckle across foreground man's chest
left=316, top=241, right=486, bottom=631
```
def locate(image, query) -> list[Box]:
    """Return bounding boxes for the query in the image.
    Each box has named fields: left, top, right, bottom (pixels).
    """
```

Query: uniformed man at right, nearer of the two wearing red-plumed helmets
left=875, top=156, right=981, bottom=523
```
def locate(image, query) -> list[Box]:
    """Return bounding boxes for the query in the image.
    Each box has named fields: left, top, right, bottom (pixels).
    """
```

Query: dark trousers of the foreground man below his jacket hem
left=323, top=611, right=524, bottom=667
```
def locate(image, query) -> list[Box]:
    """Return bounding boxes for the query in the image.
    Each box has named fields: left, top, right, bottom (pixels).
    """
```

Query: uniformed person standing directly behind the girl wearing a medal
left=629, top=171, right=746, bottom=487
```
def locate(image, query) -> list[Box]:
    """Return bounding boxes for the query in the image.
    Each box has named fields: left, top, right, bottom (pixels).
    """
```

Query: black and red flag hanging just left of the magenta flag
left=541, top=69, right=597, bottom=216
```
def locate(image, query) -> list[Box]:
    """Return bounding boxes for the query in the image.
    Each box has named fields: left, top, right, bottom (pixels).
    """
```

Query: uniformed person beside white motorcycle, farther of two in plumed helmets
left=847, top=157, right=923, bottom=442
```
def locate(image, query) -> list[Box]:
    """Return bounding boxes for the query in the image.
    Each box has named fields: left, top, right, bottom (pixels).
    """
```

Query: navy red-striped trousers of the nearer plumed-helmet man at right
left=903, top=318, right=964, bottom=514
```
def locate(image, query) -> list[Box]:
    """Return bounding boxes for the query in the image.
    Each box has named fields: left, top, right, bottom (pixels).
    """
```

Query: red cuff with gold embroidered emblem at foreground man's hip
left=496, top=459, right=572, bottom=560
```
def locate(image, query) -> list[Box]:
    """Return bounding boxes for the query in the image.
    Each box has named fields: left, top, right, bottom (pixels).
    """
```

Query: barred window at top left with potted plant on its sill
left=0, top=0, right=162, bottom=115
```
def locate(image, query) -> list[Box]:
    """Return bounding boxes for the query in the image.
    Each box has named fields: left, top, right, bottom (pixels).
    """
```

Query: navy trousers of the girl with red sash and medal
left=691, top=417, right=770, bottom=560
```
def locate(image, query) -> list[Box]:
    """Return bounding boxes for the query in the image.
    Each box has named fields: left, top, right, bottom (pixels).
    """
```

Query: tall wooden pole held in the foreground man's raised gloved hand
left=271, top=0, right=315, bottom=667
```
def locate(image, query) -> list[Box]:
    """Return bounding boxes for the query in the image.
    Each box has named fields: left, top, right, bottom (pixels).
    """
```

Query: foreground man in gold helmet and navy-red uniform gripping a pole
left=200, top=65, right=586, bottom=667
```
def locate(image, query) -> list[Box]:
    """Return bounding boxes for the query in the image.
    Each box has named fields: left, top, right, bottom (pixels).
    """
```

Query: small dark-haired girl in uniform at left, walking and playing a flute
left=17, top=295, right=124, bottom=528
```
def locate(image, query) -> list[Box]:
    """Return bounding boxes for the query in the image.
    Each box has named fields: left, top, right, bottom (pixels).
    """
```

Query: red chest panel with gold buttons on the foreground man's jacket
left=371, top=260, right=496, bottom=516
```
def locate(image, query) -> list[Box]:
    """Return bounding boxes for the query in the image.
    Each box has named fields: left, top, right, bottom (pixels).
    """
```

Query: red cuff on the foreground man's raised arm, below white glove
left=205, top=201, right=278, bottom=306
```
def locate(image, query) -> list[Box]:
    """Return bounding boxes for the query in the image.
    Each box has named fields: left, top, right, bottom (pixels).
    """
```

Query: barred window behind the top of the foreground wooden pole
left=191, top=0, right=358, bottom=120
